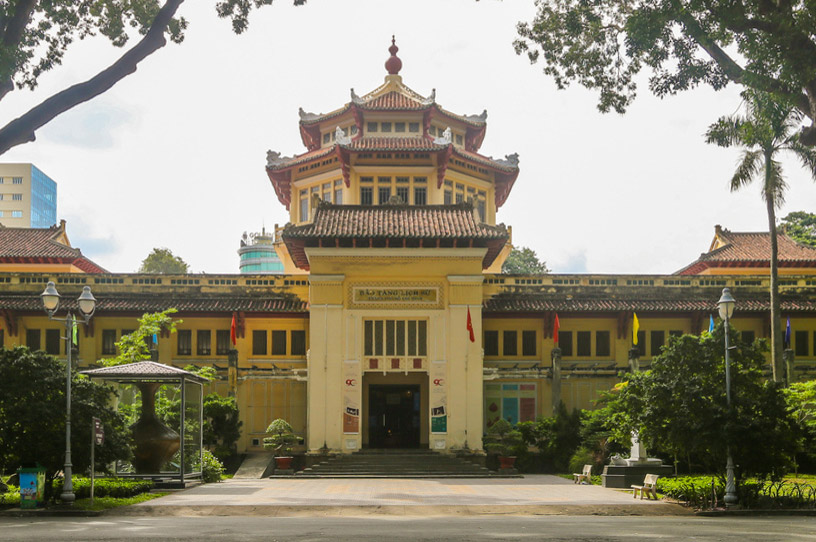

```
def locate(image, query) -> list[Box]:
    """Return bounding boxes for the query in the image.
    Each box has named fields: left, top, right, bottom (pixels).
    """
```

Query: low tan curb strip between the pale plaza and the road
left=105, top=503, right=692, bottom=517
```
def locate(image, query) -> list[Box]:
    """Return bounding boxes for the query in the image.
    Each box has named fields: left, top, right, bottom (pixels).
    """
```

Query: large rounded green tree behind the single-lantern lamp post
left=608, top=324, right=797, bottom=477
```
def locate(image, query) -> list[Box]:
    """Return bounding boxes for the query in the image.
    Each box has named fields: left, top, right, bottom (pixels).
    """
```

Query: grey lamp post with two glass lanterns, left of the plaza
left=40, top=282, right=96, bottom=505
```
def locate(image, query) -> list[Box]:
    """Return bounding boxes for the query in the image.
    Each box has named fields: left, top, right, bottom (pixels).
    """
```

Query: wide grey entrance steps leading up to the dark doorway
left=295, top=449, right=510, bottom=478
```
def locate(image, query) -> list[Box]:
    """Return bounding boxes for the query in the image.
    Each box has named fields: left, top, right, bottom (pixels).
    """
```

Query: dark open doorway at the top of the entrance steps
left=368, top=385, right=420, bottom=448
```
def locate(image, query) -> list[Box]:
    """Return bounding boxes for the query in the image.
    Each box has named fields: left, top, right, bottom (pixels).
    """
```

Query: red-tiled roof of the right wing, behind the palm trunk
left=675, top=225, right=816, bottom=275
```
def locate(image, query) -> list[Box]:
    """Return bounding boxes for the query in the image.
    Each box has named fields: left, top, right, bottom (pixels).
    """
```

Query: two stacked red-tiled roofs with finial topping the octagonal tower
left=266, top=40, right=519, bottom=209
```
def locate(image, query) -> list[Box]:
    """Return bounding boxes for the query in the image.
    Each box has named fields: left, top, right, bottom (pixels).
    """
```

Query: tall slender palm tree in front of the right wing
left=706, top=90, right=816, bottom=382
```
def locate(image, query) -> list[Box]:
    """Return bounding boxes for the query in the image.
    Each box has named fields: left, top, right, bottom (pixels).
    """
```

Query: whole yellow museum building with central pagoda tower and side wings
left=0, top=42, right=816, bottom=453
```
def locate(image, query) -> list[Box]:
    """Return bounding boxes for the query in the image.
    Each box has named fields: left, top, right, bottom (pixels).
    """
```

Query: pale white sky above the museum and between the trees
left=0, top=0, right=816, bottom=273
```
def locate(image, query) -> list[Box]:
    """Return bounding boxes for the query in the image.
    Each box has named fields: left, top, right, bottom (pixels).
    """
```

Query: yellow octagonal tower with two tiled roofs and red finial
left=266, top=38, right=519, bottom=234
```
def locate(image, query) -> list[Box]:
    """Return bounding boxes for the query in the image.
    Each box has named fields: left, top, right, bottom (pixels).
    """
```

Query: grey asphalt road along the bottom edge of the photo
left=0, top=516, right=816, bottom=542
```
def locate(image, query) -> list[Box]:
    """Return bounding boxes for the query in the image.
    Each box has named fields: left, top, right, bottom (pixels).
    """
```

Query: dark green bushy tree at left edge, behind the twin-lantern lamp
left=0, top=346, right=130, bottom=483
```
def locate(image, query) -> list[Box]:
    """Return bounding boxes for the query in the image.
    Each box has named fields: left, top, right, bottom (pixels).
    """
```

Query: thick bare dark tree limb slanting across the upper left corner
left=0, top=0, right=184, bottom=155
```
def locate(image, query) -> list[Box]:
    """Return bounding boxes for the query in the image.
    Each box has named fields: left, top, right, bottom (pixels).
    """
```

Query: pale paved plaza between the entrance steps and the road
left=116, top=475, right=690, bottom=516
